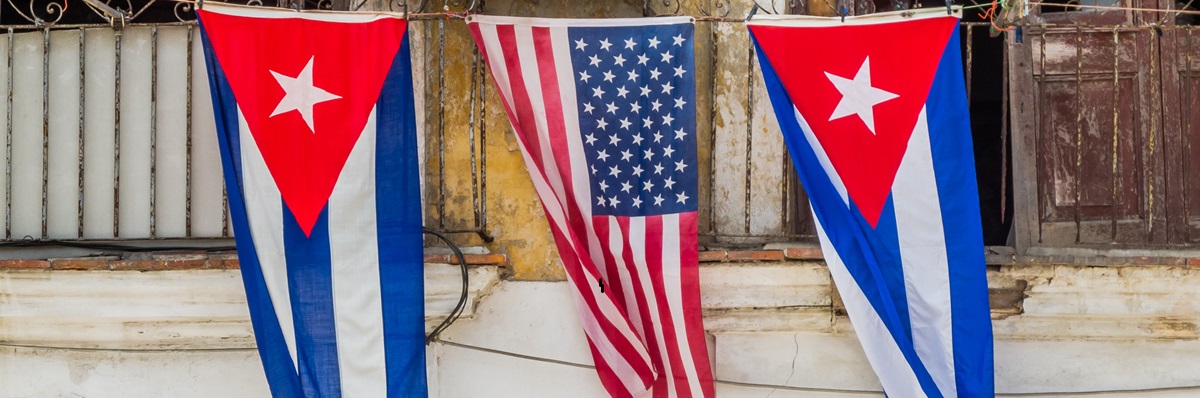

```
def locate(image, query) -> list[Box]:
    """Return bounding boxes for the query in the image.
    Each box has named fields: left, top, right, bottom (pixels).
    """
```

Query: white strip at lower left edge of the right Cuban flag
left=812, top=206, right=925, bottom=397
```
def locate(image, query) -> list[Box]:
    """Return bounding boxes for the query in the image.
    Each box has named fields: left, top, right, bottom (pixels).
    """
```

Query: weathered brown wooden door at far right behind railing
left=1010, top=0, right=1200, bottom=248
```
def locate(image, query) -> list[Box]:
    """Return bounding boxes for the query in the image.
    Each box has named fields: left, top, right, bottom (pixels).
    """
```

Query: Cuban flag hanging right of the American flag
left=748, top=12, right=994, bottom=397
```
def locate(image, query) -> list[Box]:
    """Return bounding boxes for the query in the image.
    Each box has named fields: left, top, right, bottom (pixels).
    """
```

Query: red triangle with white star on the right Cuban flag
left=750, top=17, right=959, bottom=227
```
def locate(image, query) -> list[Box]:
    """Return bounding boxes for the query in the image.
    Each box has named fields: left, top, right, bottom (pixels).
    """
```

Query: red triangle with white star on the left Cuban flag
left=199, top=10, right=407, bottom=236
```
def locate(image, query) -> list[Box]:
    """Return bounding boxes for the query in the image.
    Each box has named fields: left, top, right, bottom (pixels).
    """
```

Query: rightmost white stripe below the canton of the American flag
left=662, top=213, right=704, bottom=397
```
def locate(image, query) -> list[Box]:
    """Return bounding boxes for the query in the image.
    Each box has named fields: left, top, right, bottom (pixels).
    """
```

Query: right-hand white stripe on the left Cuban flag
left=329, top=109, right=388, bottom=397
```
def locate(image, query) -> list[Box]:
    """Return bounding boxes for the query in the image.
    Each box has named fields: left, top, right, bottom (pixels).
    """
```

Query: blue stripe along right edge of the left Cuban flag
left=376, top=35, right=427, bottom=397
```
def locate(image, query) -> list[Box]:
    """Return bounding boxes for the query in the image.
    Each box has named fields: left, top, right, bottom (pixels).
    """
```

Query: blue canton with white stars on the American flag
left=569, top=24, right=698, bottom=216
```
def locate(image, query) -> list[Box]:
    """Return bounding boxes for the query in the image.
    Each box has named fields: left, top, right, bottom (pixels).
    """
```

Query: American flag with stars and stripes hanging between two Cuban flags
left=468, top=16, right=713, bottom=397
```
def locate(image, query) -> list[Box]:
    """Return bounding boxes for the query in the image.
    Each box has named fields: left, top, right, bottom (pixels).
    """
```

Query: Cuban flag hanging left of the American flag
left=198, top=2, right=427, bottom=398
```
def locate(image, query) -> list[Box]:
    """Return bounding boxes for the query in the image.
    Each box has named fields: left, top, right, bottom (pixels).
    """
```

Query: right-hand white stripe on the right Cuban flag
left=892, top=108, right=958, bottom=398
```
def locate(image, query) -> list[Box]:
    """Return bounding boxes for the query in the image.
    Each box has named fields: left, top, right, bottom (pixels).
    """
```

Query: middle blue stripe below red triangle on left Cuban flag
left=281, top=208, right=342, bottom=397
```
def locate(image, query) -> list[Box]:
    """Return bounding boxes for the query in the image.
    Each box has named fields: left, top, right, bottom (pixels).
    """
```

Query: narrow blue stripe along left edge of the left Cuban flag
left=200, top=24, right=301, bottom=397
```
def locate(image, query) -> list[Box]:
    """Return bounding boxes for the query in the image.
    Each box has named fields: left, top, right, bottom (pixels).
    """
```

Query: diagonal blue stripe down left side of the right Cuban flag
left=750, top=32, right=942, bottom=397
